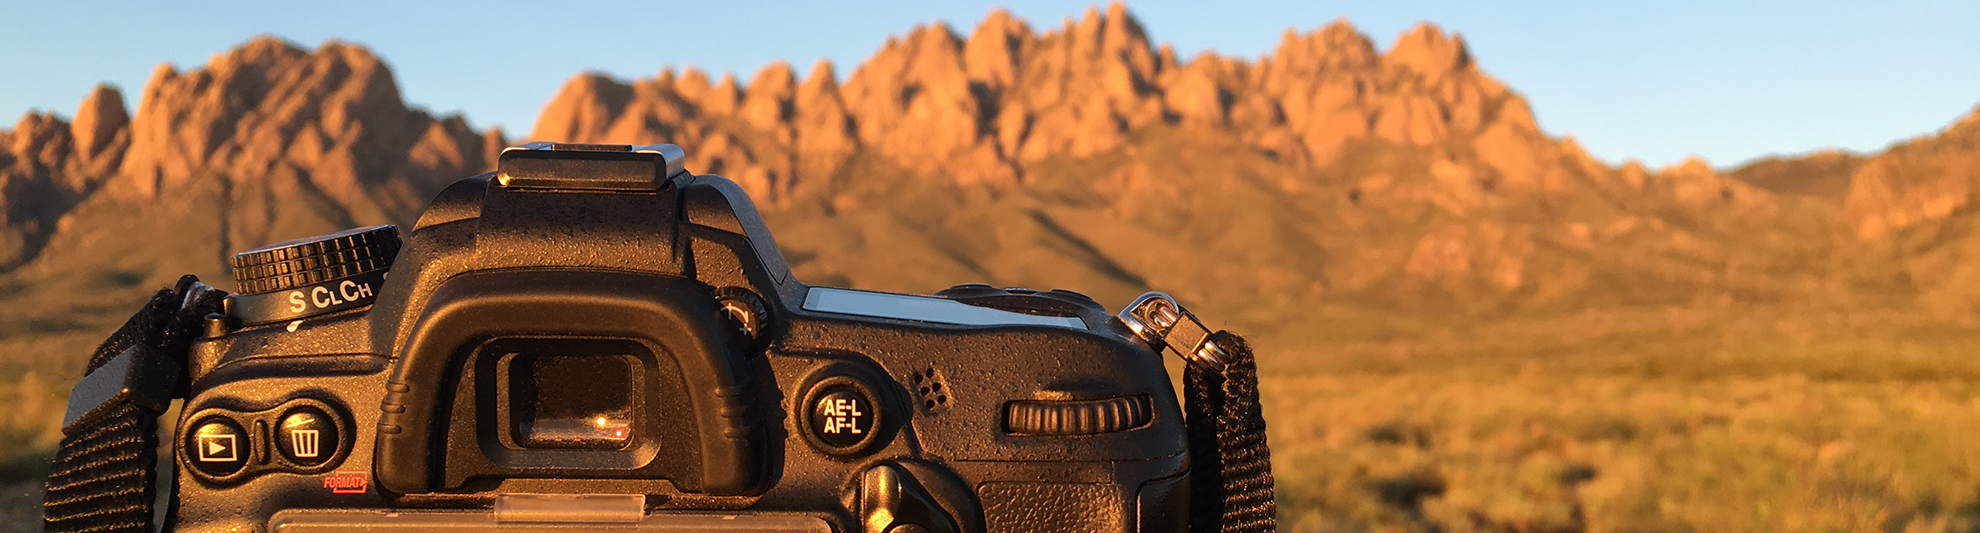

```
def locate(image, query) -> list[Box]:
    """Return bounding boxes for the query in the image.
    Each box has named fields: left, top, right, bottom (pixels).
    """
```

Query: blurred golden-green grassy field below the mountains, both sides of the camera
left=0, top=305, right=1980, bottom=531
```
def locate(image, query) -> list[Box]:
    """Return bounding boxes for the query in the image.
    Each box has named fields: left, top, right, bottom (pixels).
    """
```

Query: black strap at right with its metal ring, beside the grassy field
left=1121, top=291, right=1279, bottom=533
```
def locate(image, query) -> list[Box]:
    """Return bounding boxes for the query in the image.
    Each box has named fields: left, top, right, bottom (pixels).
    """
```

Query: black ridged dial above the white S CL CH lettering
left=234, top=224, right=398, bottom=295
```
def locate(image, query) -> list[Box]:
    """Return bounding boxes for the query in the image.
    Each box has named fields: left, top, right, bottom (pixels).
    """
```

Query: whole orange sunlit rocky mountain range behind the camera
left=0, top=4, right=1980, bottom=367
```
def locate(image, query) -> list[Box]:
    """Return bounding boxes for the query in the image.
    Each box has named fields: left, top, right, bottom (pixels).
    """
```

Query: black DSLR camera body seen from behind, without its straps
left=168, top=143, right=1190, bottom=533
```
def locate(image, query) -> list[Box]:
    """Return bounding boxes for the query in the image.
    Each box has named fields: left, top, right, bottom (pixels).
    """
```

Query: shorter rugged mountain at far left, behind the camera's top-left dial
left=0, top=36, right=505, bottom=266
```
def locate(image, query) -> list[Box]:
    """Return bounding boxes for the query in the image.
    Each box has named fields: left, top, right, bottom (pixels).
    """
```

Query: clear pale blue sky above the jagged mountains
left=0, top=0, right=1980, bottom=166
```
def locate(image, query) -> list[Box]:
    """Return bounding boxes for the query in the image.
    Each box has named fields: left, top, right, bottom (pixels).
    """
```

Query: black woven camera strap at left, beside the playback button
left=42, top=273, right=226, bottom=533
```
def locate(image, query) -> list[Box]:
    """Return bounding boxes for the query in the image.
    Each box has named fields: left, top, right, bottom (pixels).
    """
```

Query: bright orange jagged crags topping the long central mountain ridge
left=531, top=4, right=1544, bottom=204
